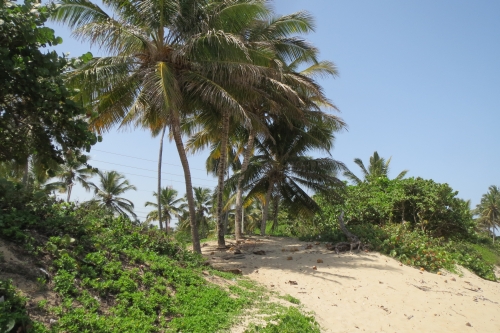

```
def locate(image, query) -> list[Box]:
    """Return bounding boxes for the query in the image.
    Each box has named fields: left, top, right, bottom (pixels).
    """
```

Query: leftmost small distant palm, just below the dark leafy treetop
left=45, top=154, right=97, bottom=202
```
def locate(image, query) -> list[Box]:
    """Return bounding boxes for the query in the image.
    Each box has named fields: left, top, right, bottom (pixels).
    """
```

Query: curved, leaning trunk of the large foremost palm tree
left=171, top=115, right=201, bottom=253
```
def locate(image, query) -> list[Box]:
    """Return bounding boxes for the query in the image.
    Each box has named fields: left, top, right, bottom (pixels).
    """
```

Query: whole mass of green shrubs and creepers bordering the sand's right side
left=279, top=177, right=500, bottom=280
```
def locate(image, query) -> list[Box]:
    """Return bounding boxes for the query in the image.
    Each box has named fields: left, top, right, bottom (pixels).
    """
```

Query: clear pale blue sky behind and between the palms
left=45, top=0, right=500, bottom=223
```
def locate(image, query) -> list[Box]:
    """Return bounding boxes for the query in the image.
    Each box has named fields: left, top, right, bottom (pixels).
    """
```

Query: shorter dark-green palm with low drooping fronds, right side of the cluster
left=239, top=112, right=345, bottom=235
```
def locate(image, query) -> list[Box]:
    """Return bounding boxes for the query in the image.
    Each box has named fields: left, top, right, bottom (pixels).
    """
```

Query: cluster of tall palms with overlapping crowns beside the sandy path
left=53, top=0, right=345, bottom=252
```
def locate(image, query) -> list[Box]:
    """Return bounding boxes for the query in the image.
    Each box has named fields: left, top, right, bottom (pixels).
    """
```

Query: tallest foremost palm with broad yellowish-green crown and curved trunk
left=54, top=0, right=277, bottom=252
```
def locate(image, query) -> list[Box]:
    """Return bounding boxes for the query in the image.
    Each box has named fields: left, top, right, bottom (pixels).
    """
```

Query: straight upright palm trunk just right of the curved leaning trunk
left=217, top=110, right=229, bottom=249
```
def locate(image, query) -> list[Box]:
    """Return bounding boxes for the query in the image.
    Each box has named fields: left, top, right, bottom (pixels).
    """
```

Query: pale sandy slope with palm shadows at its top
left=202, top=237, right=500, bottom=333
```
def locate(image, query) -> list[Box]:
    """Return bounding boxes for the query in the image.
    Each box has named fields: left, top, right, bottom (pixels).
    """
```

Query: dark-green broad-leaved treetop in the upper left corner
left=0, top=1, right=97, bottom=167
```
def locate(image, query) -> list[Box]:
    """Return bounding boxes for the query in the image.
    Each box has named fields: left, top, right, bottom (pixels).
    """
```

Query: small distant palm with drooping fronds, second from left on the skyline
left=87, top=171, right=137, bottom=218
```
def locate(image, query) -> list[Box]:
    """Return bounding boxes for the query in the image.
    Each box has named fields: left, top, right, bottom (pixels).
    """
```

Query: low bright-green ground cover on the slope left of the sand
left=0, top=181, right=313, bottom=332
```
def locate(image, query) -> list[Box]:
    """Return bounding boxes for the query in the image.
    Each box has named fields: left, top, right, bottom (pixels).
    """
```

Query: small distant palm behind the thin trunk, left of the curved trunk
left=144, top=187, right=184, bottom=232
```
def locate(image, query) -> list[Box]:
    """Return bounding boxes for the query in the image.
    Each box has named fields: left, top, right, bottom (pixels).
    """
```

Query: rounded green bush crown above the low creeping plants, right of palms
left=312, top=177, right=475, bottom=238
